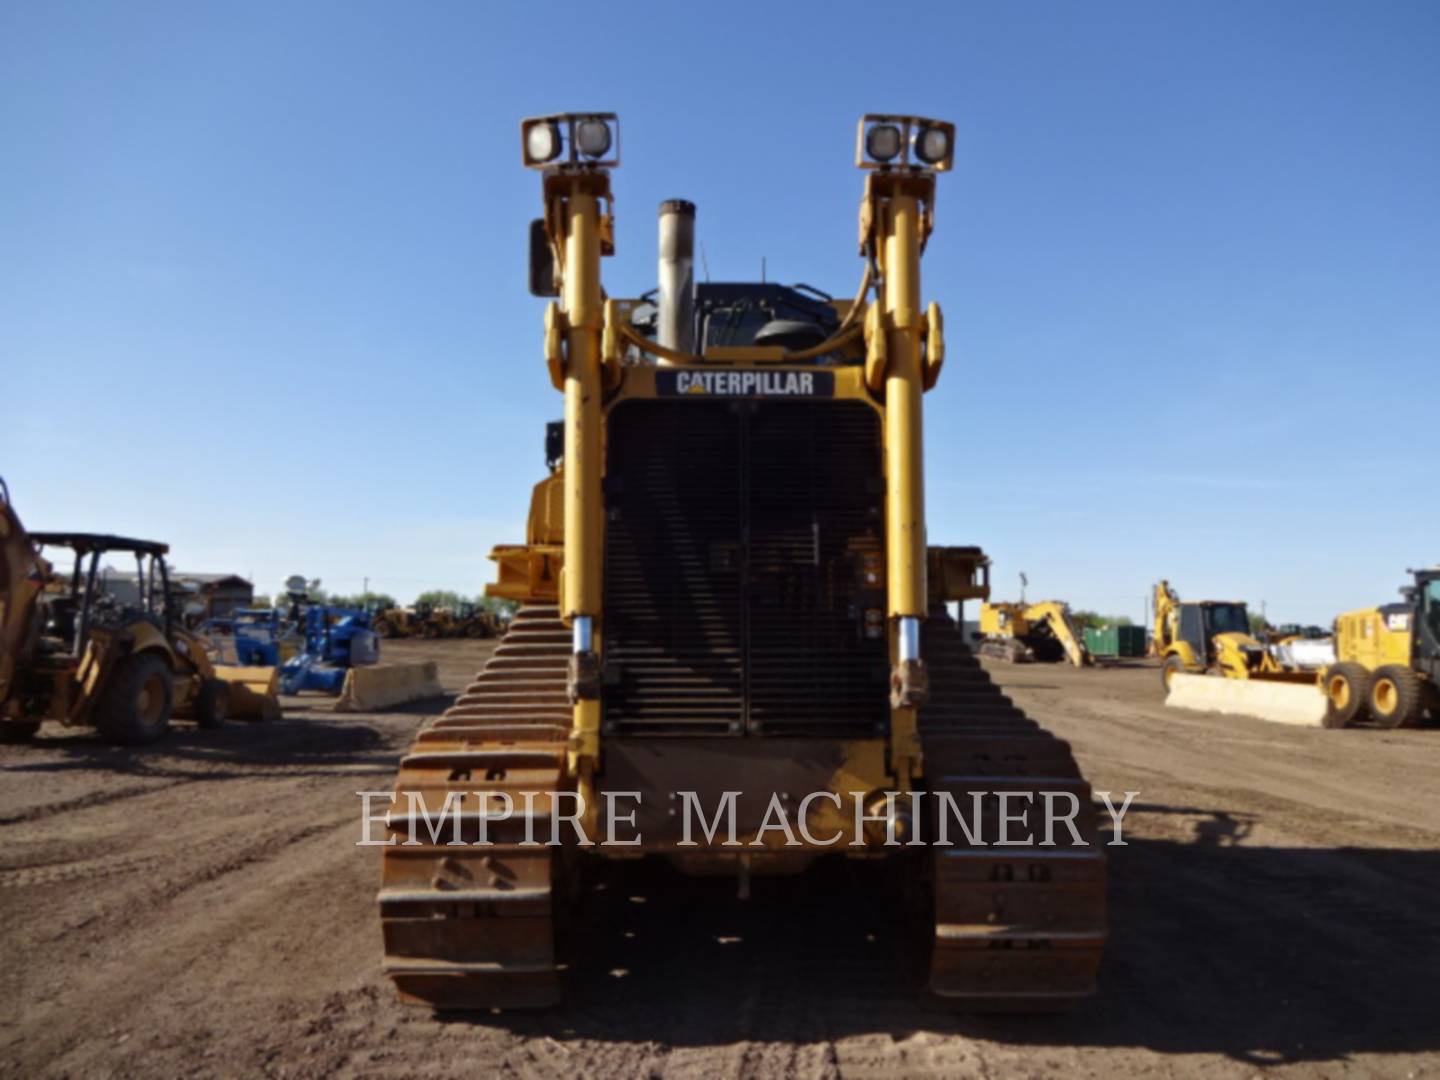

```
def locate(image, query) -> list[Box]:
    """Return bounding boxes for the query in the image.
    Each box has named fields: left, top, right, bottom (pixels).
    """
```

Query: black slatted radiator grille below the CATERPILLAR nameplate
left=603, top=400, right=888, bottom=734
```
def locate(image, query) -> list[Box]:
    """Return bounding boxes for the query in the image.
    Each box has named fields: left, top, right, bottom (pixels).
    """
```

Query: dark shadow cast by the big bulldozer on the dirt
left=446, top=806, right=1440, bottom=1067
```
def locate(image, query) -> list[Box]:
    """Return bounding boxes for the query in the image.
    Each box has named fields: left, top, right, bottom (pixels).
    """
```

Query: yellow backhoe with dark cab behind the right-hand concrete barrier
left=1155, top=580, right=1315, bottom=690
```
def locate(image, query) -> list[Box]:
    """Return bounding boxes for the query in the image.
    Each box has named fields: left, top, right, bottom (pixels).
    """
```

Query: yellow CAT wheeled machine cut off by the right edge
left=1320, top=567, right=1440, bottom=727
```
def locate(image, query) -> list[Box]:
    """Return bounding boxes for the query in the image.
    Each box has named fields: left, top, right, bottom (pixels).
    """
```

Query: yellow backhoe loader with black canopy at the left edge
left=0, top=485, right=276, bottom=746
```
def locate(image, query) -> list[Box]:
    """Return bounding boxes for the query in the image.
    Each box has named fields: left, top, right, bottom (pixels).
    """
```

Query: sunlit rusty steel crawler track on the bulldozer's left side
left=379, top=605, right=572, bottom=1009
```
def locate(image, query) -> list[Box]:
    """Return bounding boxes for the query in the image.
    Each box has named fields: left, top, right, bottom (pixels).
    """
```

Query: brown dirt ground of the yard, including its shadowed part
left=0, top=642, right=1440, bottom=1077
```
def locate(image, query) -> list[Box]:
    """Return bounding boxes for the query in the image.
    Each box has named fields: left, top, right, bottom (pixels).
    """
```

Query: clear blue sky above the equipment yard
left=0, top=0, right=1440, bottom=622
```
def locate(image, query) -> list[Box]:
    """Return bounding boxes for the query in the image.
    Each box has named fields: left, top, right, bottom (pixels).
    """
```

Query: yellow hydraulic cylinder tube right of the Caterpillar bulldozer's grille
left=880, top=194, right=926, bottom=619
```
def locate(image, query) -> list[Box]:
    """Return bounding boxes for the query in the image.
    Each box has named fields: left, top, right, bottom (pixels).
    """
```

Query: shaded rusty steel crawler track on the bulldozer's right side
left=919, top=608, right=1106, bottom=1012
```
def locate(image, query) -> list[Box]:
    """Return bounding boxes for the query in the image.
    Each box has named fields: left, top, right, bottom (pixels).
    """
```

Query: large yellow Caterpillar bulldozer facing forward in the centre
left=376, top=114, right=1106, bottom=1011
